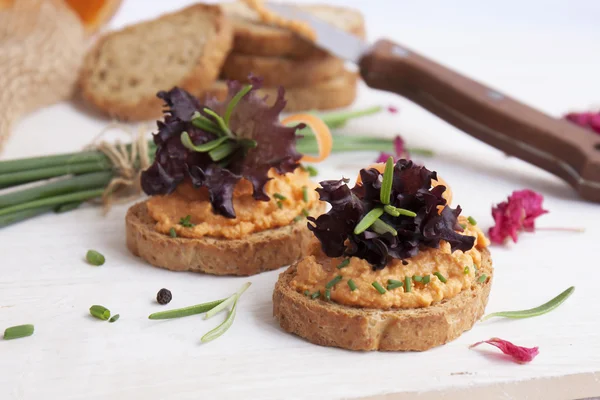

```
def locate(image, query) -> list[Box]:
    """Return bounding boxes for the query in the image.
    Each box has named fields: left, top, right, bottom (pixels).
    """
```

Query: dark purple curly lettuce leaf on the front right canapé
left=308, top=159, right=475, bottom=269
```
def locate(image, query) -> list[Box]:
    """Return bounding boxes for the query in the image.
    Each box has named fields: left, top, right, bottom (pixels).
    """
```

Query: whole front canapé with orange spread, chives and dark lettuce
left=273, top=160, right=493, bottom=351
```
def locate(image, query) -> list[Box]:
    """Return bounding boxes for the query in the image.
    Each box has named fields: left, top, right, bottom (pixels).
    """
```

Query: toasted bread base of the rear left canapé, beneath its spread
left=125, top=202, right=325, bottom=276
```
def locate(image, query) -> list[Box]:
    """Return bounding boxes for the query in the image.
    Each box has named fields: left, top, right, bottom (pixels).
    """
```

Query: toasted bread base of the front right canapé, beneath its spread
left=273, top=249, right=493, bottom=351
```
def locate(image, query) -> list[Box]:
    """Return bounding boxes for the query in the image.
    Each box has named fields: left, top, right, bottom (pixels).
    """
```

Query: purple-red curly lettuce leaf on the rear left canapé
left=141, top=79, right=302, bottom=218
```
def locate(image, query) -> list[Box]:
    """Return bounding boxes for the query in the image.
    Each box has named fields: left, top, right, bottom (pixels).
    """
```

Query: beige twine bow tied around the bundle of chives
left=89, top=122, right=151, bottom=214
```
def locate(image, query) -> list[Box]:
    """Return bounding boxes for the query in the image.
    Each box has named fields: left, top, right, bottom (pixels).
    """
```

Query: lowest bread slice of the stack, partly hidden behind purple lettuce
left=205, top=71, right=358, bottom=112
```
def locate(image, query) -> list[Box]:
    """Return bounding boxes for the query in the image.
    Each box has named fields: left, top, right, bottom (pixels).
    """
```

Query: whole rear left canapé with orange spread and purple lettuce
left=126, top=79, right=331, bottom=275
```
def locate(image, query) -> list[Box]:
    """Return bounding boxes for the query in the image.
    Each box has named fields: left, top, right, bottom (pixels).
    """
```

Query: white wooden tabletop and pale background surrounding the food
left=0, top=0, right=600, bottom=400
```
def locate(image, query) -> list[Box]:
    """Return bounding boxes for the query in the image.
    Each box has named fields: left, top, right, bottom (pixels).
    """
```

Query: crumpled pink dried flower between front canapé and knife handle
left=488, top=189, right=548, bottom=244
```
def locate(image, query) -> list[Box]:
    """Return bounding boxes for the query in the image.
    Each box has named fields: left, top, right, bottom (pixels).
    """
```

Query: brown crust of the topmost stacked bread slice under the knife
left=223, top=3, right=366, bottom=59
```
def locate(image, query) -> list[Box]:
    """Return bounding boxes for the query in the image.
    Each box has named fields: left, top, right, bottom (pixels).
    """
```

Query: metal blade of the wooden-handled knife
left=266, top=2, right=369, bottom=63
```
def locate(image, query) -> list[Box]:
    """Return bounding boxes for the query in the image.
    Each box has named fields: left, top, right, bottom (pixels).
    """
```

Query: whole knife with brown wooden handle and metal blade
left=267, top=3, right=600, bottom=202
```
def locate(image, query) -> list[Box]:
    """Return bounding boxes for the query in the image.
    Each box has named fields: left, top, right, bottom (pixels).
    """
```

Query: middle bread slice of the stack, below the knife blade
left=221, top=53, right=344, bottom=88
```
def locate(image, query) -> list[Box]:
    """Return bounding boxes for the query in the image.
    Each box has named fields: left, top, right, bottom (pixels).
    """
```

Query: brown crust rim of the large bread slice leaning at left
left=80, top=4, right=233, bottom=121
